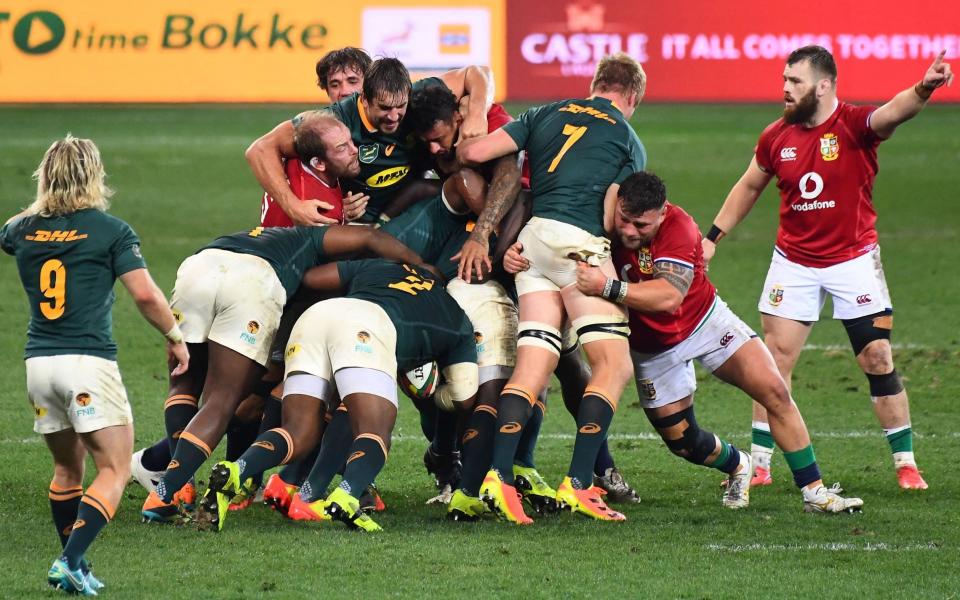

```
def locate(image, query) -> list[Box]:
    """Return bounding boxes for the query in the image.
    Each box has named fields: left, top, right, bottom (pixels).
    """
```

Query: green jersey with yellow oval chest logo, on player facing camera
left=327, top=77, right=444, bottom=222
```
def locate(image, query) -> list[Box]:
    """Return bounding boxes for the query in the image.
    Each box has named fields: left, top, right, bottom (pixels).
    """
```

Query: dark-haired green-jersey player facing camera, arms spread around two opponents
left=246, top=58, right=493, bottom=225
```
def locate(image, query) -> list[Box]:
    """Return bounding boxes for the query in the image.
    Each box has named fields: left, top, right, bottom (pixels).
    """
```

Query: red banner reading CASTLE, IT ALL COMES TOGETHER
left=507, top=0, right=960, bottom=102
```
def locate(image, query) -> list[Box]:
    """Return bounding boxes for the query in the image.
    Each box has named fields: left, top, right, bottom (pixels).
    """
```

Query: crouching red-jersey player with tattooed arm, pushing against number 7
left=507, top=172, right=863, bottom=513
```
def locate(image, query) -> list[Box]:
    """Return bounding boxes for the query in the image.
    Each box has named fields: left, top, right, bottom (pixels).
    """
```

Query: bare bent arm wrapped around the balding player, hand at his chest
left=244, top=115, right=337, bottom=225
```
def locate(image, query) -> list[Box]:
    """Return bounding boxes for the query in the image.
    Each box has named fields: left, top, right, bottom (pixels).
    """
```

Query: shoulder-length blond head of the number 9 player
left=30, top=133, right=113, bottom=217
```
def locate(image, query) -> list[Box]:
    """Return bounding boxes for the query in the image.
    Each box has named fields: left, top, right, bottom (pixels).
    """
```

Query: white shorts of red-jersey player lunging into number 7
left=630, top=296, right=757, bottom=408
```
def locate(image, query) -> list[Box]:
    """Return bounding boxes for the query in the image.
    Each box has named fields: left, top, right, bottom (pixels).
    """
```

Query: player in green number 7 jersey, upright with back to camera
left=457, top=53, right=646, bottom=524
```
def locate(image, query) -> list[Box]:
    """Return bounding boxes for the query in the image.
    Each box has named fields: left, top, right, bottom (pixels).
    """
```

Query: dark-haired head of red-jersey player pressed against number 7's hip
left=613, top=171, right=667, bottom=250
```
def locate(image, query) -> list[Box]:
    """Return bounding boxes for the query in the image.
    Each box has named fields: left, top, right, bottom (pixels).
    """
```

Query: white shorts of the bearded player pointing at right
left=757, top=246, right=893, bottom=322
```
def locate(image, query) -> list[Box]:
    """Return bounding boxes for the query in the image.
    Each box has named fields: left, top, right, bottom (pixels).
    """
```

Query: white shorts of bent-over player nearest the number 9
left=170, top=248, right=287, bottom=366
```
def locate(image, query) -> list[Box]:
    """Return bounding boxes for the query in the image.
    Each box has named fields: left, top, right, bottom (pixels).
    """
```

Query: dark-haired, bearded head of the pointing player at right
left=783, top=46, right=837, bottom=123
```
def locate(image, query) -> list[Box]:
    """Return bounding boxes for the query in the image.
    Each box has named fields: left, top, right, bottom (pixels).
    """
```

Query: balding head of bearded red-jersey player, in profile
left=293, top=110, right=360, bottom=177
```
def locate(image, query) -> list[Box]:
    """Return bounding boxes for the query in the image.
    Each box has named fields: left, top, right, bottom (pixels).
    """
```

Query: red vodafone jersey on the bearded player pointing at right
left=756, top=102, right=882, bottom=268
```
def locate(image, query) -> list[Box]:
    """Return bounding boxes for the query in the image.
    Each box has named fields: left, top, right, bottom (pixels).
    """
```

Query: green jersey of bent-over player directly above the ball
left=337, top=259, right=477, bottom=371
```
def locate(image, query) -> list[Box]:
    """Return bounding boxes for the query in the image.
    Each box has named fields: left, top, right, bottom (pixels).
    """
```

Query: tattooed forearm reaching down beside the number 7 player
left=454, top=153, right=520, bottom=283
